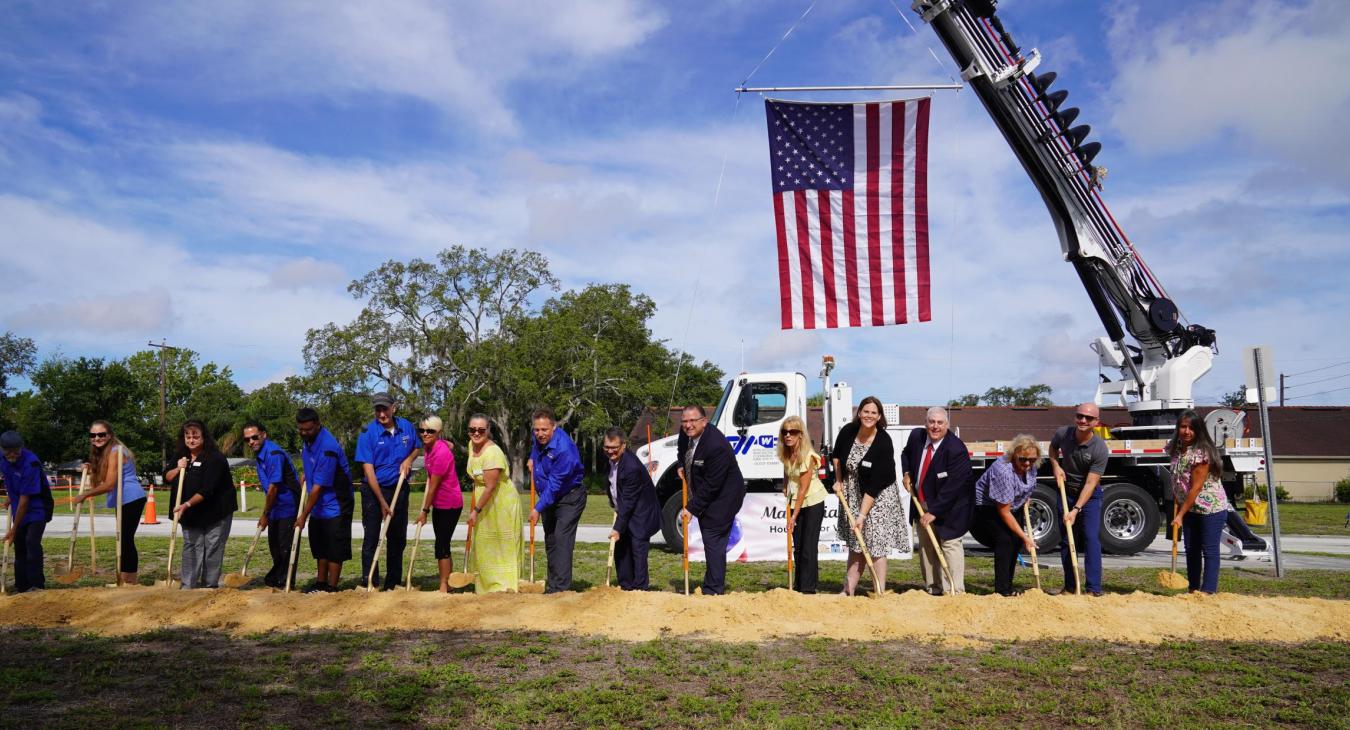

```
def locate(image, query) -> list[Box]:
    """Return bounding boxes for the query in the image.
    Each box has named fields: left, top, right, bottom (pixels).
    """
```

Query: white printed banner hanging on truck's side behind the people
left=689, top=490, right=914, bottom=563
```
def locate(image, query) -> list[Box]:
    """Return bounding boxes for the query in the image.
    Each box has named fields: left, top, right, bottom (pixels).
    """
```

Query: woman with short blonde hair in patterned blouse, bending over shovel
left=975, top=433, right=1041, bottom=595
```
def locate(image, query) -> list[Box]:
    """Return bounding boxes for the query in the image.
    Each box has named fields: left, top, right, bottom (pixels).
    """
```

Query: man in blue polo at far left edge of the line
left=0, top=430, right=53, bottom=594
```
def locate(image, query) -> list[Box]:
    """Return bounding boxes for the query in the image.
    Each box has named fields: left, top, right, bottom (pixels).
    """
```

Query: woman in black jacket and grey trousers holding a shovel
left=165, top=420, right=239, bottom=588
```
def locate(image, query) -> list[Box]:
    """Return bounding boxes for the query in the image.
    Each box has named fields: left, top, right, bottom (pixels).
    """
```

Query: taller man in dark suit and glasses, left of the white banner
left=678, top=406, right=745, bottom=595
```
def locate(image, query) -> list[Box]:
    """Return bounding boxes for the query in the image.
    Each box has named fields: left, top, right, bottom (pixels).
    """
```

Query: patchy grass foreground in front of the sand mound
left=0, top=629, right=1350, bottom=729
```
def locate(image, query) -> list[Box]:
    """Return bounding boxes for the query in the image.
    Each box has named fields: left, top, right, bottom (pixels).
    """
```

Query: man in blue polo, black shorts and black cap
left=296, top=408, right=354, bottom=592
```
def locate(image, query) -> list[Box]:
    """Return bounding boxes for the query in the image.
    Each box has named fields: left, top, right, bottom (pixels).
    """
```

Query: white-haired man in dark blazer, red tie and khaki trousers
left=900, top=406, right=975, bottom=595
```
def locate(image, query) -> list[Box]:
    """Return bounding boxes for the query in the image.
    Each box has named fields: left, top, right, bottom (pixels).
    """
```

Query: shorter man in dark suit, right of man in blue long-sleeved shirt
left=605, top=428, right=662, bottom=591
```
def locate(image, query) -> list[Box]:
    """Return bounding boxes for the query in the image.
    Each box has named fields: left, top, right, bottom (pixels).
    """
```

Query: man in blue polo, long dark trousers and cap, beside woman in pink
left=356, top=393, right=421, bottom=591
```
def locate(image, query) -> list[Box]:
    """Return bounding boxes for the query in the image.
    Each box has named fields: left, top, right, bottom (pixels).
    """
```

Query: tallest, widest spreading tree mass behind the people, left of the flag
left=303, top=247, right=721, bottom=480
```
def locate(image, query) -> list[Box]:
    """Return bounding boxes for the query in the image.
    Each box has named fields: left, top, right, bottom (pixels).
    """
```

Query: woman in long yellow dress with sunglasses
left=466, top=413, right=522, bottom=594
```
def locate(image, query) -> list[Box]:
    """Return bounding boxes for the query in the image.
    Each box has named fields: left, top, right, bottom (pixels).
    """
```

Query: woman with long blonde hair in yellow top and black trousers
left=778, top=416, right=825, bottom=594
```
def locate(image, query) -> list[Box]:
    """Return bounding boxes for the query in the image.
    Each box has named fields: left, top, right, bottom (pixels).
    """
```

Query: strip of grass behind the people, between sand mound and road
left=26, top=529, right=1350, bottom=599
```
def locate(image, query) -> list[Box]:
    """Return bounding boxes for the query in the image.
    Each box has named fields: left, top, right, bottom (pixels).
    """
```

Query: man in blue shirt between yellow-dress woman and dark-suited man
left=529, top=408, right=586, bottom=594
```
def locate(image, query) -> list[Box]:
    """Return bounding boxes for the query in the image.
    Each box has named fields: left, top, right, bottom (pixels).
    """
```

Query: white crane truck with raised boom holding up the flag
left=640, top=0, right=1264, bottom=555
